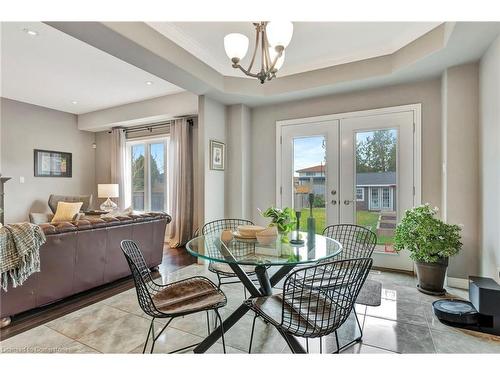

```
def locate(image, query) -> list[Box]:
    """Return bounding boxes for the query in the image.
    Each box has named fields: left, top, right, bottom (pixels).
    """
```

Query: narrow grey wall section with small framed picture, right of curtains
left=198, top=95, right=227, bottom=227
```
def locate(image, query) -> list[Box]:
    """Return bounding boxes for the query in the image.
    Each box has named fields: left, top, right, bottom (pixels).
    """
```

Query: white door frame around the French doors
left=276, top=103, right=422, bottom=207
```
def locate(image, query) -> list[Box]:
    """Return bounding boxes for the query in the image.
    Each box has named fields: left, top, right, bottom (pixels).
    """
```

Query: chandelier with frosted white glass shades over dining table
left=224, top=21, right=293, bottom=83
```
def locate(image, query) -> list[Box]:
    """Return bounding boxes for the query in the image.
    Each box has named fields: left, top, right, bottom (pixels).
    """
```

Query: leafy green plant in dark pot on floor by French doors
left=394, top=203, right=462, bottom=295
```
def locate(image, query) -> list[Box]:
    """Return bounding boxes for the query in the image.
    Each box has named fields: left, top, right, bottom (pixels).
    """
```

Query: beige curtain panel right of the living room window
left=168, top=118, right=193, bottom=247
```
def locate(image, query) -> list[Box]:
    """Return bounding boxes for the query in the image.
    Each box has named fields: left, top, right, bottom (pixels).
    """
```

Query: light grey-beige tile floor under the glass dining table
left=0, top=264, right=500, bottom=354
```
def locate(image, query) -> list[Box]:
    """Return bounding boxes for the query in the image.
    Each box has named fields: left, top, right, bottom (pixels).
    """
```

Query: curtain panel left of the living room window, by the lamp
left=111, top=127, right=126, bottom=210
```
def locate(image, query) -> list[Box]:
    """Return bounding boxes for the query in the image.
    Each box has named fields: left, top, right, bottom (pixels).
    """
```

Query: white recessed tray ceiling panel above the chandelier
left=148, top=22, right=440, bottom=77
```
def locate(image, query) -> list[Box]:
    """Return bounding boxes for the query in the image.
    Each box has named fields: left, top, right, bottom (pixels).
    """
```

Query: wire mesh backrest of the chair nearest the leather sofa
left=120, top=240, right=158, bottom=316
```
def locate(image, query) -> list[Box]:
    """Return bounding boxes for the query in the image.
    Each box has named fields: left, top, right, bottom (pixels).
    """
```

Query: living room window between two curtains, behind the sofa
left=125, top=137, right=169, bottom=212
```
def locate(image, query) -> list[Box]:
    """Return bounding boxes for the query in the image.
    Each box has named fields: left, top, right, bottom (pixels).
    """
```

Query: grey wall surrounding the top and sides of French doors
left=251, top=79, right=441, bottom=223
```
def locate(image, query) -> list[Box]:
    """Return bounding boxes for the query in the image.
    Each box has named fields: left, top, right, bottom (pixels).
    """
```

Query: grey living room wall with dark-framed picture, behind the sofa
left=1, top=98, right=96, bottom=223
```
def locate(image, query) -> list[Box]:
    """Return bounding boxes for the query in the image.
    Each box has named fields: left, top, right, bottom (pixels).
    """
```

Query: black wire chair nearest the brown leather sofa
left=120, top=240, right=227, bottom=353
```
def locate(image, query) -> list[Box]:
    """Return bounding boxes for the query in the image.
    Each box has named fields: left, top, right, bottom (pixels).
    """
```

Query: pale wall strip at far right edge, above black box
left=479, top=37, right=500, bottom=282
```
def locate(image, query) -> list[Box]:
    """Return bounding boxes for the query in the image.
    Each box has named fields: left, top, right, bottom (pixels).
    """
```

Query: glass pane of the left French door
left=293, top=136, right=326, bottom=233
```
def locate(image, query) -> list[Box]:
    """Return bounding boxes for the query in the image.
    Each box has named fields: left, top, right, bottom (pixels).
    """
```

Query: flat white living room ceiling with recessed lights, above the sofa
left=1, top=22, right=183, bottom=114
